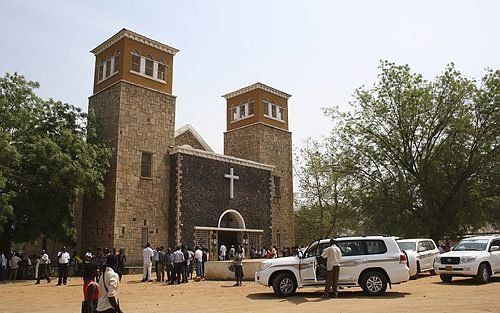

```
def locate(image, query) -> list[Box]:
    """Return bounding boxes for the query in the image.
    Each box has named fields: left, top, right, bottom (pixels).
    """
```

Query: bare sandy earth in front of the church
left=0, top=275, right=500, bottom=313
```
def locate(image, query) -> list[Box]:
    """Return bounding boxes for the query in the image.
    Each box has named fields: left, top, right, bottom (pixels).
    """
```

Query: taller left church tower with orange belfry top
left=81, top=29, right=178, bottom=264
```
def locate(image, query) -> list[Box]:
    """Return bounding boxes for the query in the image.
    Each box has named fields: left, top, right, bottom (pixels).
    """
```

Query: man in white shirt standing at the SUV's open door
left=321, top=239, right=342, bottom=298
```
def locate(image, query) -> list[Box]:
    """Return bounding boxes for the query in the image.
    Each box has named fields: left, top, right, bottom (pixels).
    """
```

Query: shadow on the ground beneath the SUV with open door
left=247, top=291, right=410, bottom=304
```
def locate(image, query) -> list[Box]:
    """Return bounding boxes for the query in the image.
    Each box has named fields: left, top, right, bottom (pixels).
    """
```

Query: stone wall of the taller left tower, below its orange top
left=83, top=81, right=175, bottom=265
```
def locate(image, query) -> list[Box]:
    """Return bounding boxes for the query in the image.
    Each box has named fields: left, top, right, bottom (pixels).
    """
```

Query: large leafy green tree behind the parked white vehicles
left=327, top=62, right=500, bottom=239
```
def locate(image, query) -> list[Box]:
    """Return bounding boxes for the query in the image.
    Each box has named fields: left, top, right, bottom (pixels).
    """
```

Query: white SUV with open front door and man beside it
left=255, top=236, right=409, bottom=296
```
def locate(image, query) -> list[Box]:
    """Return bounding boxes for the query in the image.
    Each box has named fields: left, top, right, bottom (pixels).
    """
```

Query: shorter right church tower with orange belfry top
left=223, top=83, right=294, bottom=248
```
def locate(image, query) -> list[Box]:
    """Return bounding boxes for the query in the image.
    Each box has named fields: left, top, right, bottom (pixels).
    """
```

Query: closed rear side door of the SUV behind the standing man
left=337, top=240, right=367, bottom=284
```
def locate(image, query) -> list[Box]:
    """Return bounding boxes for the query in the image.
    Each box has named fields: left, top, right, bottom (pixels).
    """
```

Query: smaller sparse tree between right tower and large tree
left=295, top=138, right=360, bottom=244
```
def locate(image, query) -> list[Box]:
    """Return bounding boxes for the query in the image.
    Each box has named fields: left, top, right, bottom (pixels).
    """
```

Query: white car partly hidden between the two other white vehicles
left=398, top=239, right=440, bottom=278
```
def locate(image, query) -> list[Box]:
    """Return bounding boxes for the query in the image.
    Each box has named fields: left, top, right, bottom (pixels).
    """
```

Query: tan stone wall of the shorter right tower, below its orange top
left=224, top=123, right=295, bottom=248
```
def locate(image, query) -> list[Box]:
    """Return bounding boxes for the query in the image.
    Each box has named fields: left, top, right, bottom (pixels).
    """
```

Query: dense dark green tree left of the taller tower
left=0, top=74, right=111, bottom=248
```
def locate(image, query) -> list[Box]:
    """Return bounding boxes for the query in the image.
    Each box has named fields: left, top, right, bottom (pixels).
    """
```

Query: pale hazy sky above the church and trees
left=0, top=0, right=500, bottom=153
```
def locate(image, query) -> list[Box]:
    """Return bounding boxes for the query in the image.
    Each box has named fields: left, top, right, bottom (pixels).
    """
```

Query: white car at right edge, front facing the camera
left=434, top=235, right=500, bottom=283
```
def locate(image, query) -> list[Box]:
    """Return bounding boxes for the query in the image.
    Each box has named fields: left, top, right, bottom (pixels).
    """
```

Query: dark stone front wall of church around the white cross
left=169, top=153, right=271, bottom=246
